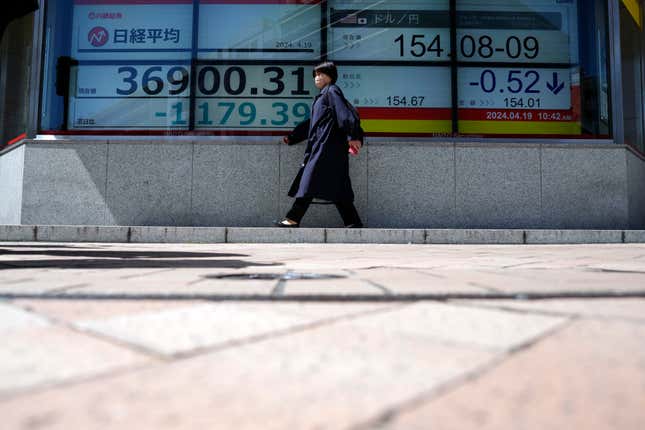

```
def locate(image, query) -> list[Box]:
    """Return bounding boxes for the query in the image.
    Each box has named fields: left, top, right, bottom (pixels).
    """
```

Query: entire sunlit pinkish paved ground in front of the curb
left=0, top=242, right=645, bottom=430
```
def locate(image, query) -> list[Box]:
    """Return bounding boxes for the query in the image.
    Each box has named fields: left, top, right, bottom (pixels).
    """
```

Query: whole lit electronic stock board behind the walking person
left=68, top=0, right=581, bottom=135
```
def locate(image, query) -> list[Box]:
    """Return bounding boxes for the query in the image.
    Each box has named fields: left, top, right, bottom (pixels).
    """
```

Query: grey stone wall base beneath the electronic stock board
left=0, top=138, right=645, bottom=229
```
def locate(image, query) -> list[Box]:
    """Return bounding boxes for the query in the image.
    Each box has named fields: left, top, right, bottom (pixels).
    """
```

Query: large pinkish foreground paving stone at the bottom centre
left=0, top=316, right=495, bottom=430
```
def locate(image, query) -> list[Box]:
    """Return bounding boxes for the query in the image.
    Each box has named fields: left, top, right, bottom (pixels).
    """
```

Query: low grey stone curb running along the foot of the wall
left=0, top=225, right=645, bottom=245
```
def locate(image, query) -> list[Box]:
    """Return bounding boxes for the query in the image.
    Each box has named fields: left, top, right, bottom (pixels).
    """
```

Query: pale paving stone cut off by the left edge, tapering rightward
left=0, top=327, right=148, bottom=394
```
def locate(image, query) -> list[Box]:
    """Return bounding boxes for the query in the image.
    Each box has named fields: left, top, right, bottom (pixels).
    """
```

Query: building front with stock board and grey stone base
left=0, top=0, right=645, bottom=228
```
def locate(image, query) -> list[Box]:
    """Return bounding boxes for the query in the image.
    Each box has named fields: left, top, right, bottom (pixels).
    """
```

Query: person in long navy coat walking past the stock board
left=274, top=62, right=363, bottom=228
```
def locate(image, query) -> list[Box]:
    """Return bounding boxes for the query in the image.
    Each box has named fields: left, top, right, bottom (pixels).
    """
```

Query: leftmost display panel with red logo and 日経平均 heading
left=66, top=0, right=193, bottom=130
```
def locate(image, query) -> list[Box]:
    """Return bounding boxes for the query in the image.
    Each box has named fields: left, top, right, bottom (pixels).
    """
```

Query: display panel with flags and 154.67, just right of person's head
left=327, top=0, right=452, bottom=135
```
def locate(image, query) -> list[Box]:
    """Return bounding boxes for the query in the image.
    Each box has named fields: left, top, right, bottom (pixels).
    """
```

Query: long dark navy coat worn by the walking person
left=288, top=84, right=363, bottom=202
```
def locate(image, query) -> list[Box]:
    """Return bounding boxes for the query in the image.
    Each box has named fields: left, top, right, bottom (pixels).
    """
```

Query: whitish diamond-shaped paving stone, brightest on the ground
left=77, top=303, right=388, bottom=356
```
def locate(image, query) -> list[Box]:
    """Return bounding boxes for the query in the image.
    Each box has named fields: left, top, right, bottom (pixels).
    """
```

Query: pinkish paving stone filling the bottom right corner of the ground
left=379, top=320, right=645, bottom=430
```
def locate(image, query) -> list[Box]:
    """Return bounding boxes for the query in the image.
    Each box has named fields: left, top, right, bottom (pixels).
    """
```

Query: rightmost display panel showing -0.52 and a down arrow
left=457, top=0, right=581, bottom=135
